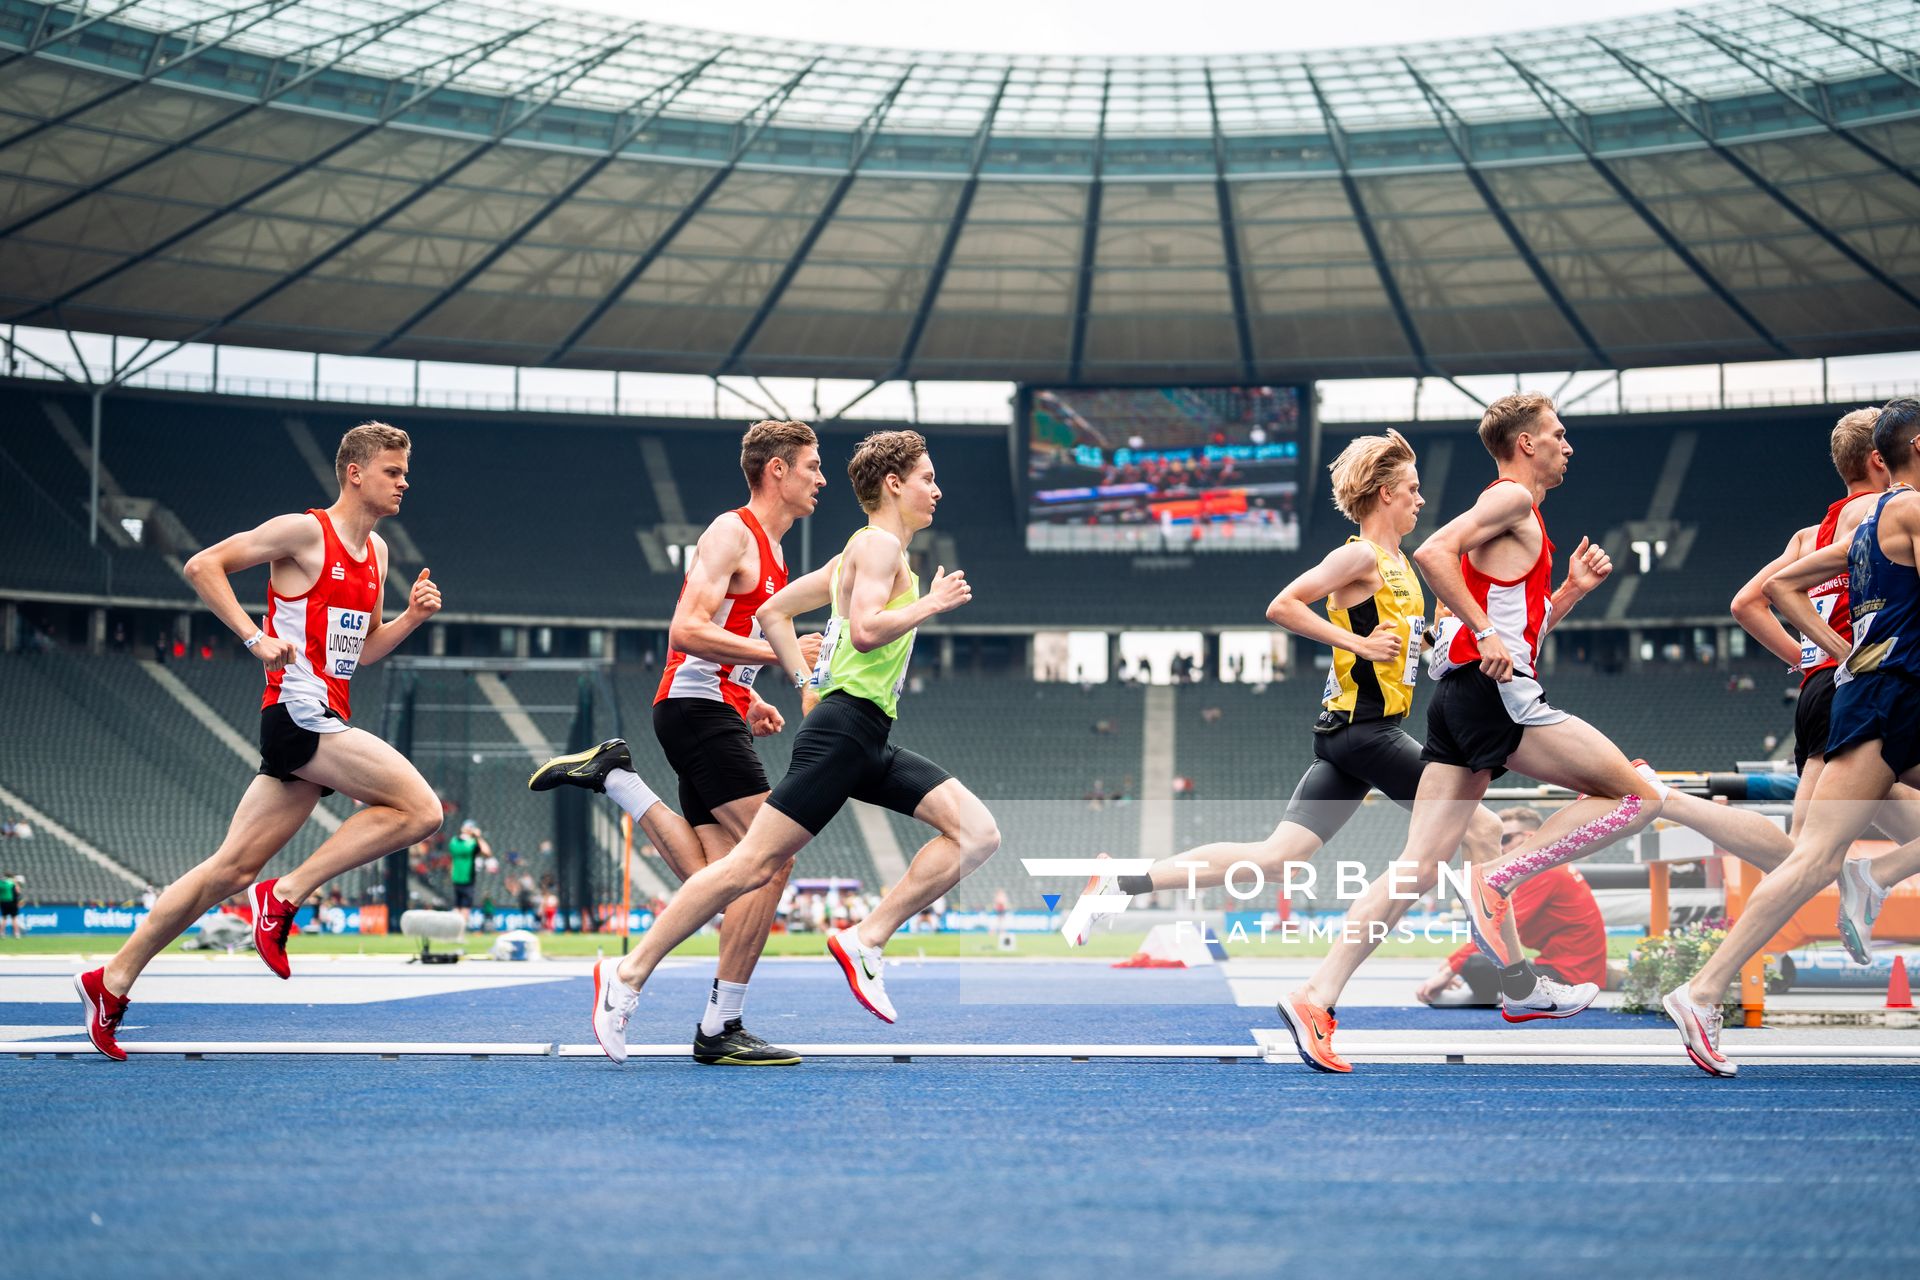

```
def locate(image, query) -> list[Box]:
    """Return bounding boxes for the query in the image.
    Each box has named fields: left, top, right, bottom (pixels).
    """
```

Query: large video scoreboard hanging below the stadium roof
left=1021, top=386, right=1308, bottom=553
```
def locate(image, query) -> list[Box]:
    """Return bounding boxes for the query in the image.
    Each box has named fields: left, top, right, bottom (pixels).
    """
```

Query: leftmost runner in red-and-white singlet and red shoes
left=73, top=422, right=442, bottom=1059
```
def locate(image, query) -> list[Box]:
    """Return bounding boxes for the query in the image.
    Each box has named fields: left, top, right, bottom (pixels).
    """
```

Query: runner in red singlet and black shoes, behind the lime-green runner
left=528, top=420, right=826, bottom=1067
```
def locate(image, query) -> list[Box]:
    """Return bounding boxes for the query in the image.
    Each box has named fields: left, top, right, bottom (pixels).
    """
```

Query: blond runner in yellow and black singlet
left=1079, top=430, right=1536, bottom=990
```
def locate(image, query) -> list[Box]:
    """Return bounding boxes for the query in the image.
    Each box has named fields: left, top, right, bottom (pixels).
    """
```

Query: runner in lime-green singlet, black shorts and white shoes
left=593, top=432, right=1000, bottom=1061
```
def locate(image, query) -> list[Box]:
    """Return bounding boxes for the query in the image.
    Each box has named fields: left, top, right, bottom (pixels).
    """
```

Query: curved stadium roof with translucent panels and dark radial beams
left=0, top=0, right=1920, bottom=382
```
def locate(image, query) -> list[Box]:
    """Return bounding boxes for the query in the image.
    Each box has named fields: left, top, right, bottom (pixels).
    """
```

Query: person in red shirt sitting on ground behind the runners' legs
left=1413, top=806, right=1607, bottom=1007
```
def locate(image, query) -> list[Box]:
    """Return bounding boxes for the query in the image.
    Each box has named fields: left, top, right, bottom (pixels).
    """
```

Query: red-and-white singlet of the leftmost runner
left=259, top=510, right=380, bottom=720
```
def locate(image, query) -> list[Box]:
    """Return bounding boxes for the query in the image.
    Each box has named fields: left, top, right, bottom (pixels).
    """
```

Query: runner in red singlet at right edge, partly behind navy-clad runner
left=1734, top=409, right=1920, bottom=965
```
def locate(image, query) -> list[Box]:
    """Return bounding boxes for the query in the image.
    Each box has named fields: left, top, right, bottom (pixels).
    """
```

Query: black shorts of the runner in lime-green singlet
left=766, top=691, right=952, bottom=835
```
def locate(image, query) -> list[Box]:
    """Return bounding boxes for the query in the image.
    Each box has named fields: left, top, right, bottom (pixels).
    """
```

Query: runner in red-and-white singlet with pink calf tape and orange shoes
left=1279, top=393, right=1786, bottom=1071
